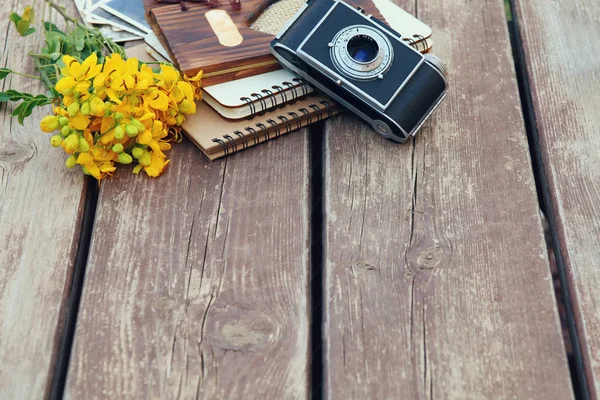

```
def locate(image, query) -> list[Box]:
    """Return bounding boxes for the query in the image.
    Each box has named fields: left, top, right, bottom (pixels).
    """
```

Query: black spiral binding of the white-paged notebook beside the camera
left=240, top=78, right=310, bottom=119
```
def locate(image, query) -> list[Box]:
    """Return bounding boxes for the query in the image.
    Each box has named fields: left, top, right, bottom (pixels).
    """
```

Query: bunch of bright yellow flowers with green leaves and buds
left=0, top=2, right=202, bottom=181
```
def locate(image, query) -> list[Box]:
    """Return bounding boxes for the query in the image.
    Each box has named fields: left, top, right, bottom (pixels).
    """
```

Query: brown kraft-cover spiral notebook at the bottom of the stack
left=182, top=95, right=341, bottom=160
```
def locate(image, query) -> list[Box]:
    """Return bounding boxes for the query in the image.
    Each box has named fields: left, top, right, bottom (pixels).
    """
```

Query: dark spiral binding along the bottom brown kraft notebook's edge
left=212, top=100, right=336, bottom=156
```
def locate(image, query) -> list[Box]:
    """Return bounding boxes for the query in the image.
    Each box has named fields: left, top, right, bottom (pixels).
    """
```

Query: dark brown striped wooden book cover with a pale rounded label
left=144, top=0, right=385, bottom=86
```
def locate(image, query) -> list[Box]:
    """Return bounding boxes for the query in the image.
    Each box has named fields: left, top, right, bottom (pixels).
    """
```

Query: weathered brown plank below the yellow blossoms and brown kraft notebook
left=65, top=136, right=309, bottom=399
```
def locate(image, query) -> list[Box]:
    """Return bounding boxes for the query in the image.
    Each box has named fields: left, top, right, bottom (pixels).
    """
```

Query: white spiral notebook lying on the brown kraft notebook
left=202, top=69, right=314, bottom=119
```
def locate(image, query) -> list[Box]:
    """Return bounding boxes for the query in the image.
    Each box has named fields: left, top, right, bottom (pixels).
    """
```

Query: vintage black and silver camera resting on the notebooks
left=271, top=0, right=447, bottom=143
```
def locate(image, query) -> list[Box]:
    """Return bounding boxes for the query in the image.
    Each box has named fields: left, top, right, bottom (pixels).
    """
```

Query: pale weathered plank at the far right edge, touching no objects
left=516, top=0, right=600, bottom=398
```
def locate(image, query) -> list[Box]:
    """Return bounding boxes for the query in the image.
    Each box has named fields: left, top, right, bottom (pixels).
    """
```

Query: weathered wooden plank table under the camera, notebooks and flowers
left=0, top=0, right=600, bottom=399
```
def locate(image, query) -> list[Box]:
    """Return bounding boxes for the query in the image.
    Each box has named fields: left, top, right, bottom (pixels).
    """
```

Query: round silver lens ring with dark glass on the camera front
left=329, top=25, right=394, bottom=80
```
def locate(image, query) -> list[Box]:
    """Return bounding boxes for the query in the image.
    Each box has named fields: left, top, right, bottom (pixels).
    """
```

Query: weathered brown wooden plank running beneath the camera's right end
left=323, top=0, right=573, bottom=399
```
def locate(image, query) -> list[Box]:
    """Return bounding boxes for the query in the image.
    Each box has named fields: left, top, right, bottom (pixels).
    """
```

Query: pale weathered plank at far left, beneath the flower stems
left=0, top=0, right=85, bottom=399
